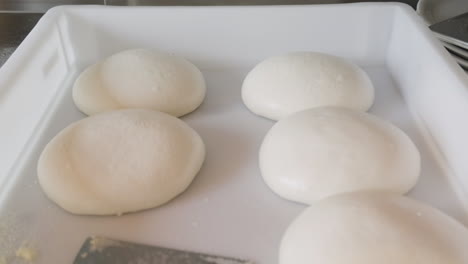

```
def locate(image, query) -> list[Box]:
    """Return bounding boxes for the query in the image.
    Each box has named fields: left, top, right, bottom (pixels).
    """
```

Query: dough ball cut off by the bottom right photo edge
left=279, top=192, right=468, bottom=264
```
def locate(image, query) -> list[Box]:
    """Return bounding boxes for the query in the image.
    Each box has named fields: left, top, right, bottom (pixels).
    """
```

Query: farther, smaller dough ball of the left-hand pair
left=73, top=49, right=206, bottom=116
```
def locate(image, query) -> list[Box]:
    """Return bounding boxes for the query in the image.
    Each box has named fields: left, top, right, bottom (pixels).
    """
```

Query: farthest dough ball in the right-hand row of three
left=242, top=52, right=374, bottom=120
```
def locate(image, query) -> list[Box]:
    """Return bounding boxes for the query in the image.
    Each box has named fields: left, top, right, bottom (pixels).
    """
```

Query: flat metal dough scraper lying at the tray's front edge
left=73, top=237, right=252, bottom=264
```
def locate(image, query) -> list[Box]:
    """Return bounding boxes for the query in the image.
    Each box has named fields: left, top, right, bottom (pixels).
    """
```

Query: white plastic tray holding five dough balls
left=0, top=4, right=468, bottom=264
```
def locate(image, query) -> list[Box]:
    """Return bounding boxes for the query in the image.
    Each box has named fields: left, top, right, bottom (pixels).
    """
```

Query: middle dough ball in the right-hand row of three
left=259, top=107, right=420, bottom=204
